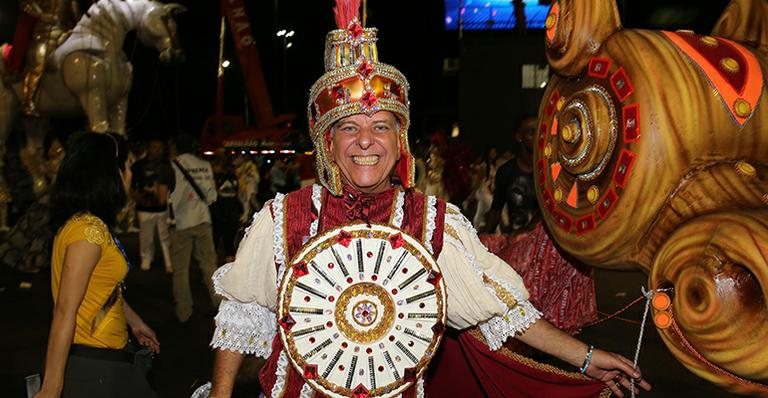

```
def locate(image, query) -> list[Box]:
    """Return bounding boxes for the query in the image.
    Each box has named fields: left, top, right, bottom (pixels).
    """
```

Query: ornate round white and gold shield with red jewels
left=277, top=224, right=446, bottom=398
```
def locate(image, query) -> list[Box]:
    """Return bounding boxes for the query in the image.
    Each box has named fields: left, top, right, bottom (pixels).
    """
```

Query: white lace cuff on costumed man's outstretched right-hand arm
left=480, top=300, right=541, bottom=351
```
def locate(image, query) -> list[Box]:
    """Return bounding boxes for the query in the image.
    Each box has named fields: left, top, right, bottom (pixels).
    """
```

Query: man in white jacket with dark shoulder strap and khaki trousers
left=171, top=134, right=219, bottom=322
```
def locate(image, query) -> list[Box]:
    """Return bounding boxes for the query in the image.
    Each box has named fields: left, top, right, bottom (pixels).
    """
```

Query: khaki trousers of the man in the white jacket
left=171, top=223, right=220, bottom=322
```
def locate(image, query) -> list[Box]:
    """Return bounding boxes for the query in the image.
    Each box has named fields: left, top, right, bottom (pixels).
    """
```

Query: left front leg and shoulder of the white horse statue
left=61, top=51, right=110, bottom=133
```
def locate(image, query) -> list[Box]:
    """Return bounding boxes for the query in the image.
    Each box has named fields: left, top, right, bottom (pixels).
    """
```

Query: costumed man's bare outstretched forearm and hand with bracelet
left=517, top=318, right=651, bottom=397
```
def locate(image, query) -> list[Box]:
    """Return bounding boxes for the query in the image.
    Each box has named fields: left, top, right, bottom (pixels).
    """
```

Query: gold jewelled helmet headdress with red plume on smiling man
left=307, top=0, right=414, bottom=196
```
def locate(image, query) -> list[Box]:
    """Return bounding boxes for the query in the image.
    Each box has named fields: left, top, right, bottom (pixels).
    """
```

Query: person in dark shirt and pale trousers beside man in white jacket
left=131, top=138, right=173, bottom=273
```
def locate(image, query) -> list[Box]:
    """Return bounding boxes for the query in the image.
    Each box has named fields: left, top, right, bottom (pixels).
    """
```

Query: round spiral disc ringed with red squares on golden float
left=536, top=58, right=640, bottom=264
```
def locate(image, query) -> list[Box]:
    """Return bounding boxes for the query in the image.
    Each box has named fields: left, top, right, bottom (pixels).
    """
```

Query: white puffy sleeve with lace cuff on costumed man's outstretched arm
left=437, top=204, right=541, bottom=350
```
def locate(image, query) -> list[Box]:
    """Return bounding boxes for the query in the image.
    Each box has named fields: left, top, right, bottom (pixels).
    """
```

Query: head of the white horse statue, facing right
left=136, top=1, right=187, bottom=62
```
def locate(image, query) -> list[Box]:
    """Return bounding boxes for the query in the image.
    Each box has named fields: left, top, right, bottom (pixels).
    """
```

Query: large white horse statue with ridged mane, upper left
left=0, top=0, right=185, bottom=143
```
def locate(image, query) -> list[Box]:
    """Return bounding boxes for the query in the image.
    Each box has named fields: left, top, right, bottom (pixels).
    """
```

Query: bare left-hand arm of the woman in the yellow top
left=35, top=240, right=101, bottom=398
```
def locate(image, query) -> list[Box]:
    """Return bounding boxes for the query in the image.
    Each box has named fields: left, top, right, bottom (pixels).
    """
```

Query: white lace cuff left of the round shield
left=211, top=300, right=277, bottom=359
